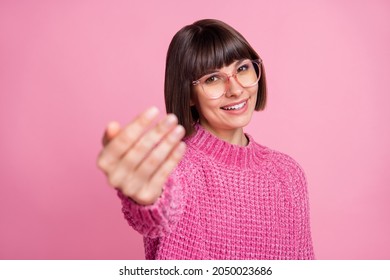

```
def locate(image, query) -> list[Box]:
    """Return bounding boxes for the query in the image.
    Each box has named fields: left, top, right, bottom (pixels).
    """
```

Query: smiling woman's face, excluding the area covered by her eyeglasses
left=191, top=60, right=258, bottom=139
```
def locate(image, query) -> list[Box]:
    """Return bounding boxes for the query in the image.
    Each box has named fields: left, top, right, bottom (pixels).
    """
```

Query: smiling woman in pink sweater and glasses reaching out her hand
left=98, top=20, right=314, bottom=259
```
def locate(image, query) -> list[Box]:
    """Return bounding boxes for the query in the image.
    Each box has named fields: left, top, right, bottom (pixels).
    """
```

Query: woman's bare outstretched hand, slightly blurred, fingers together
left=97, top=107, right=185, bottom=205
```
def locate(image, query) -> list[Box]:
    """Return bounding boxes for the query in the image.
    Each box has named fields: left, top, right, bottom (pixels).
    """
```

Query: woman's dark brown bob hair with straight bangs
left=164, top=19, right=267, bottom=136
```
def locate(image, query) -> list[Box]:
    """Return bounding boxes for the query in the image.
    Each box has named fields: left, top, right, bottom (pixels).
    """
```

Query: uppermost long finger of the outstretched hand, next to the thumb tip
left=99, top=107, right=158, bottom=169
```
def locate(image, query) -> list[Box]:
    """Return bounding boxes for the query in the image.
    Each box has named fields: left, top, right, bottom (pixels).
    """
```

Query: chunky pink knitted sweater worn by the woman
left=119, top=125, right=314, bottom=259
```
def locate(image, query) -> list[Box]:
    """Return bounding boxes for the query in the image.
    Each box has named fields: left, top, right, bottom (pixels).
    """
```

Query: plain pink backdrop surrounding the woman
left=0, top=0, right=390, bottom=259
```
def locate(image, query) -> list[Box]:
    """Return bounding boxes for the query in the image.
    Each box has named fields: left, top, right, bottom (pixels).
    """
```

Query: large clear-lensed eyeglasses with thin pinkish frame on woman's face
left=192, top=59, right=261, bottom=99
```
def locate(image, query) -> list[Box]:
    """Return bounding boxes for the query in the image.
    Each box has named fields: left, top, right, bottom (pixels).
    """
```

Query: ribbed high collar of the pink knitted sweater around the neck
left=186, top=124, right=264, bottom=168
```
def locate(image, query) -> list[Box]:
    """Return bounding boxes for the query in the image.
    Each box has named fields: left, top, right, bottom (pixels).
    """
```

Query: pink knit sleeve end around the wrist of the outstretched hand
left=118, top=166, right=186, bottom=238
